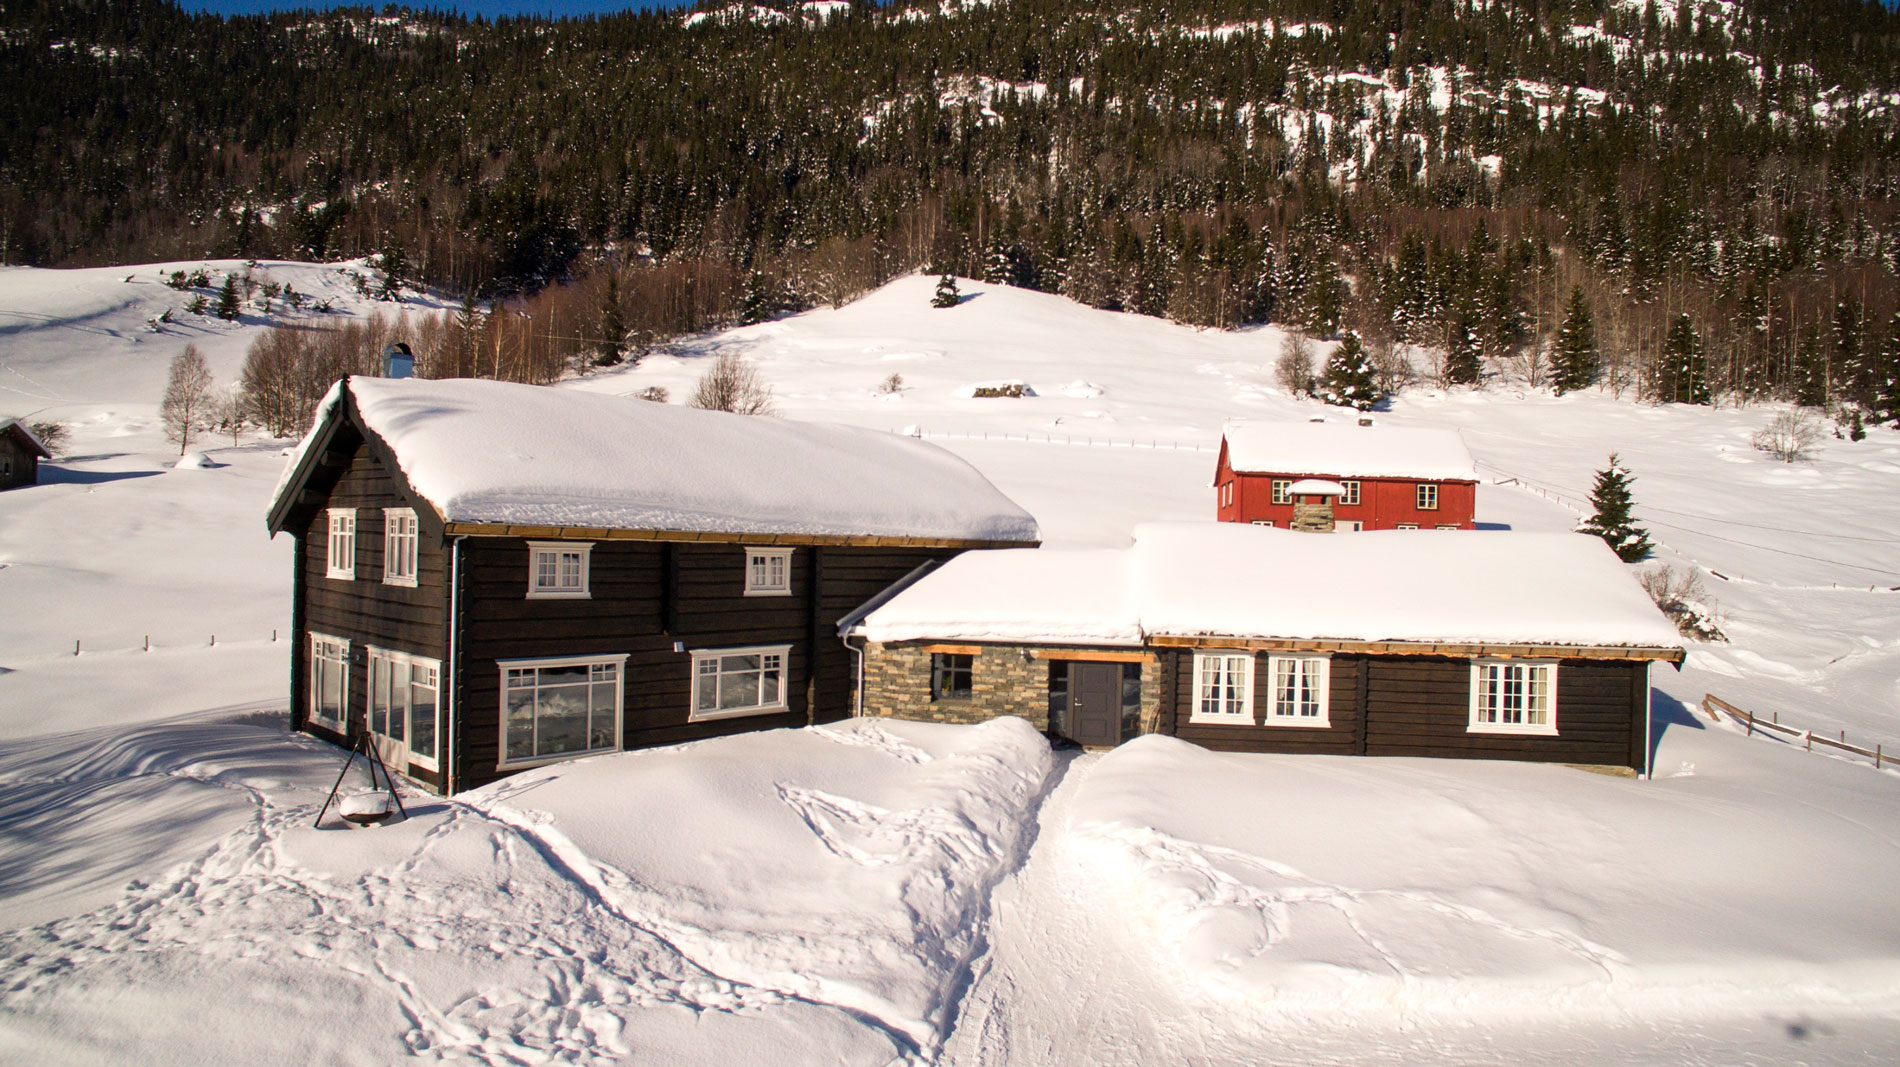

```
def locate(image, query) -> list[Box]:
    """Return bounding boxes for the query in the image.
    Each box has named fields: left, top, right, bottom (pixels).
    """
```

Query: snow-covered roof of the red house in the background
left=1224, top=421, right=1478, bottom=482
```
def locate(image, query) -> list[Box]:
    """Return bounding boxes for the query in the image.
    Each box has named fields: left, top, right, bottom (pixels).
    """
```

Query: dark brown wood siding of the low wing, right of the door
left=1157, top=649, right=1649, bottom=769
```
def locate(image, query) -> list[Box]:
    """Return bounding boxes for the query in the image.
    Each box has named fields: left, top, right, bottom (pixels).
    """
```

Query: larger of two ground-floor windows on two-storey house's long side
left=500, top=655, right=627, bottom=769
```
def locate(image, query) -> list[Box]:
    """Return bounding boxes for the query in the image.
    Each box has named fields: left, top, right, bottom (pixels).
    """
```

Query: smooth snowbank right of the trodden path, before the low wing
left=1064, top=723, right=1900, bottom=1027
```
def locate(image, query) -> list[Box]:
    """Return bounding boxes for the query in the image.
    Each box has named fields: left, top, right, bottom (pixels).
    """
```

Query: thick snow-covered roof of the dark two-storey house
left=274, top=378, right=1037, bottom=543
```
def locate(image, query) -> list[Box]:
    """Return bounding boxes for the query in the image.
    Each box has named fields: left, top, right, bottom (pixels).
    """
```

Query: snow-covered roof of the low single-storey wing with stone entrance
left=855, top=522, right=1682, bottom=649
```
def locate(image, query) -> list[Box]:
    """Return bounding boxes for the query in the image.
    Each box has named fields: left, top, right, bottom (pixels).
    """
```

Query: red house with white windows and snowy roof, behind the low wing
left=1214, top=421, right=1478, bottom=530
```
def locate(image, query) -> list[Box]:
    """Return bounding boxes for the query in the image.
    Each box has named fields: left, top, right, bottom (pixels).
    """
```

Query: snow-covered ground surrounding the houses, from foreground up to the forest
left=0, top=262, right=1900, bottom=1065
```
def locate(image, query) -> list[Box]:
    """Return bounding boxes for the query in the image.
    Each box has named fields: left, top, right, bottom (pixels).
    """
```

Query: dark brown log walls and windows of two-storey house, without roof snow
left=270, top=380, right=1034, bottom=792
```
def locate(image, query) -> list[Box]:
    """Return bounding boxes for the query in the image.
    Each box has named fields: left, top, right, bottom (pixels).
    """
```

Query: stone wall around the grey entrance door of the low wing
left=865, top=642, right=1161, bottom=733
